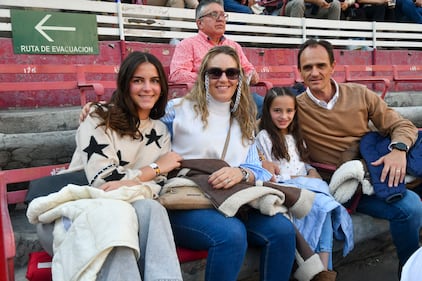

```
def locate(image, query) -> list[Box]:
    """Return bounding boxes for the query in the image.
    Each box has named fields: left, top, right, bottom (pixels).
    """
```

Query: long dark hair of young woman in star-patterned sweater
left=92, top=51, right=168, bottom=139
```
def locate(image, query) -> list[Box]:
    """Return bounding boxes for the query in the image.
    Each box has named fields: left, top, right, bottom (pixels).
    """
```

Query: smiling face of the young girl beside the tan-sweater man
left=269, top=96, right=296, bottom=134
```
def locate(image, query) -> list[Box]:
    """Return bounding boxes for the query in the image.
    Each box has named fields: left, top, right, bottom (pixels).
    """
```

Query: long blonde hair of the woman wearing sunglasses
left=185, top=46, right=257, bottom=141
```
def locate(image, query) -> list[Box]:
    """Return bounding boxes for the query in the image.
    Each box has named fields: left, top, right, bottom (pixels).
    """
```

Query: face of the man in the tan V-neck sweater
left=300, top=45, right=335, bottom=97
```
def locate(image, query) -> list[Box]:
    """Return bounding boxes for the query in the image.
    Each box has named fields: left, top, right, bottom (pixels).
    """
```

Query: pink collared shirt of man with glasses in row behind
left=169, top=31, right=255, bottom=84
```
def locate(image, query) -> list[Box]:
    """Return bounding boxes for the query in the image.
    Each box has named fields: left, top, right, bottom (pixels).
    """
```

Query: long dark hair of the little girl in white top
left=259, top=87, right=309, bottom=162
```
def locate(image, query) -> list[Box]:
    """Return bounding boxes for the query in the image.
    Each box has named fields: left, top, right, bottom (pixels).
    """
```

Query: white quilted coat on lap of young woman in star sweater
left=27, top=183, right=156, bottom=281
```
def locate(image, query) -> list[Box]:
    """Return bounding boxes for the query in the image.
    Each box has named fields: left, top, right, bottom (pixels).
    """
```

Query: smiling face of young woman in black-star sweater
left=130, top=62, right=161, bottom=120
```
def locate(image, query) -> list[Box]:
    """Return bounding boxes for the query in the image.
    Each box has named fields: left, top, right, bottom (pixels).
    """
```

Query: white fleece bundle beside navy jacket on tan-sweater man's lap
left=329, top=160, right=374, bottom=203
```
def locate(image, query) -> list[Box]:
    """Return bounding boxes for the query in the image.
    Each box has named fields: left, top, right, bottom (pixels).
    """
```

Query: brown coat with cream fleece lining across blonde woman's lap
left=167, top=159, right=324, bottom=281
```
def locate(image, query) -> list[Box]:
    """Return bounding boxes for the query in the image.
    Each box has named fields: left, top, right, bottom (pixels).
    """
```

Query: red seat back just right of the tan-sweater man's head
left=344, top=65, right=393, bottom=99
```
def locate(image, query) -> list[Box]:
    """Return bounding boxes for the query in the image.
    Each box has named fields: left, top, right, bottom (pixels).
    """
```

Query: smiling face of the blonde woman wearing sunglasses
left=207, top=53, right=239, bottom=102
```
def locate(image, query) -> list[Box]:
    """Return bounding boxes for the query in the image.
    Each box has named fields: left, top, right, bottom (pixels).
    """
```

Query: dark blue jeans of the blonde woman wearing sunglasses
left=169, top=209, right=296, bottom=281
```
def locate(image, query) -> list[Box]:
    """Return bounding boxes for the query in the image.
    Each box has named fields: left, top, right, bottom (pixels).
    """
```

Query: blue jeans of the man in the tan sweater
left=356, top=190, right=422, bottom=266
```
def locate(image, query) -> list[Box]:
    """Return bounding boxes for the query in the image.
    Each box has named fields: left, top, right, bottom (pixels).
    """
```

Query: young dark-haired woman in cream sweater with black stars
left=34, top=52, right=182, bottom=281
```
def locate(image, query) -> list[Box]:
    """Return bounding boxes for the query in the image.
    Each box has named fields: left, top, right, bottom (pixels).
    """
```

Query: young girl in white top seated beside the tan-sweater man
left=256, top=87, right=353, bottom=280
